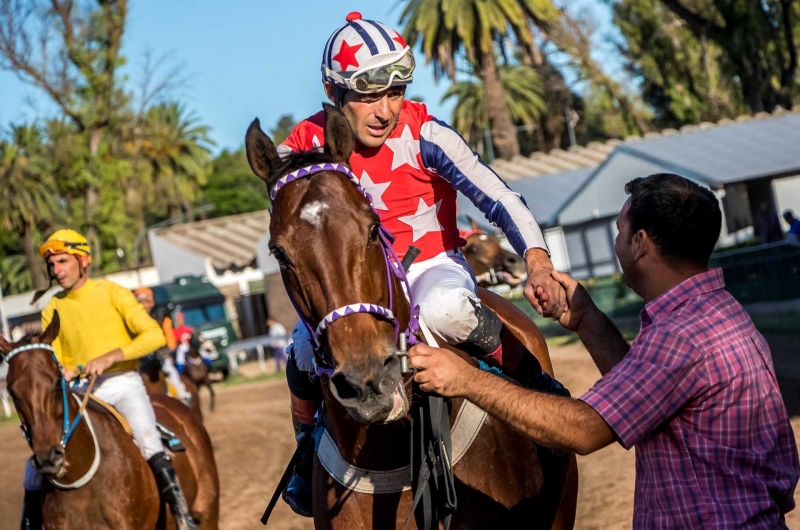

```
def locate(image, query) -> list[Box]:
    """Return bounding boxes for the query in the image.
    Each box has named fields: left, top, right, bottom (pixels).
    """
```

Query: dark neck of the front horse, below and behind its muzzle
left=322, top=270, right=411, bottom=471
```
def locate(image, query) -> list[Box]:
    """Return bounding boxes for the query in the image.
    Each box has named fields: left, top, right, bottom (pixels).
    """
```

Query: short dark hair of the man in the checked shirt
left=625, top=173, right=722, bottom=267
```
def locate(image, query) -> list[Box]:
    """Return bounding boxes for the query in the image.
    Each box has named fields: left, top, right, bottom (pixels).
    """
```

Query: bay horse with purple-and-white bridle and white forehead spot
left=245, top=105, right=577, bottom=530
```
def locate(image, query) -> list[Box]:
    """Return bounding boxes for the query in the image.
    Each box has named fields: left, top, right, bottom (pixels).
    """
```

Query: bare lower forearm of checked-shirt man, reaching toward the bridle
left=464, top=364, right=614, bottom=454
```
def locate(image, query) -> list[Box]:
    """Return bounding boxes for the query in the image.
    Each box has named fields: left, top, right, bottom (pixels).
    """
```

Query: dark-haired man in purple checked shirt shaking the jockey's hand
left=410, top=174, right=800, bottom=529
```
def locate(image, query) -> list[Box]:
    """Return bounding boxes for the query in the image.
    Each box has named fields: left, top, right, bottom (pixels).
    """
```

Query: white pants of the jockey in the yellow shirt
left=25, top=372, right=164, bottom=491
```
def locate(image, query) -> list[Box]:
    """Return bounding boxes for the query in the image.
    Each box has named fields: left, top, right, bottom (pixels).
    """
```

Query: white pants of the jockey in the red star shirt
left=287, top=249, right=480, bottom=372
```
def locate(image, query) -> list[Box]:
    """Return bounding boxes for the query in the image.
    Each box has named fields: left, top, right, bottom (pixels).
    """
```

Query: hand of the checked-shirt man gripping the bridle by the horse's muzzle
left=408, top=344, right=477, bottom=397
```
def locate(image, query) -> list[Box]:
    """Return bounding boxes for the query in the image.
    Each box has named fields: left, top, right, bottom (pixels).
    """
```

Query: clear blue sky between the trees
left=0, top=0, right=603, bottom=151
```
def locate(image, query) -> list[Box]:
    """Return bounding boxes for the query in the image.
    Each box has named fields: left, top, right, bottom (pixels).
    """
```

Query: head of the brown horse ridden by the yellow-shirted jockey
left=0, top=312, right=66, bottom=478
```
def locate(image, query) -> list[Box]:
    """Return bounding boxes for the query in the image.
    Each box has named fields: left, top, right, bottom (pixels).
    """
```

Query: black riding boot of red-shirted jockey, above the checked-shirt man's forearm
left=457, top=305, right=570, bottom=396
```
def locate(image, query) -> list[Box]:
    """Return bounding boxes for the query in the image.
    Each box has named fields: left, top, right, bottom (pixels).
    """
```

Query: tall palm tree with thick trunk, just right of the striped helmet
left=400, top=0, right=559, bottom=160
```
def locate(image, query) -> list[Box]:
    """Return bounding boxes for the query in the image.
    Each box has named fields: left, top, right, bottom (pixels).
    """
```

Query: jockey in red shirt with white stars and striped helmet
left=278, top=12, right=566, bottom=516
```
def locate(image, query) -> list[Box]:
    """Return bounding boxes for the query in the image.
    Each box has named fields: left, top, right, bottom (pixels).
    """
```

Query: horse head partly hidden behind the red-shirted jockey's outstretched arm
left=462, top=219, right=528, bottom=287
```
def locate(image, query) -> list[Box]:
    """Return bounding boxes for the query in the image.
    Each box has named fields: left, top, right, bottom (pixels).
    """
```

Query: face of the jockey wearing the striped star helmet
left=325, top=84, right=406, bottom=147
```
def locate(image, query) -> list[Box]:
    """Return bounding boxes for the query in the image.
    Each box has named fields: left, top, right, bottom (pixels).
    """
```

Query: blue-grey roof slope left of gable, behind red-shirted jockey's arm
left=458, top=167, right=595, bottom=226
